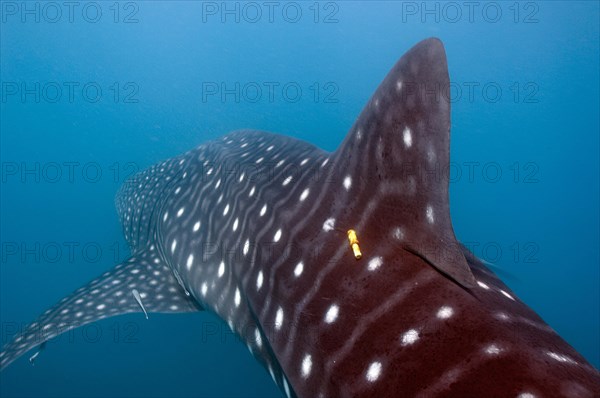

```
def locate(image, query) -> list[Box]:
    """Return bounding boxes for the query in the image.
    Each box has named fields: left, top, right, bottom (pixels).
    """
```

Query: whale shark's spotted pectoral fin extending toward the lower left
left=0, top=252, right=202, bottom=370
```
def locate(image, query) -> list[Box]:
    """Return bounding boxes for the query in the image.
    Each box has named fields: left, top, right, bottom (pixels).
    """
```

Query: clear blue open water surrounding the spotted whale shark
left=0, top=1, right=600, bottom=397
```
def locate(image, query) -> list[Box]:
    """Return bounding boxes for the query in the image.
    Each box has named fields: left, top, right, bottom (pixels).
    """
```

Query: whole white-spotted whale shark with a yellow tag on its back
left=0, top=38, right=600, bottom=398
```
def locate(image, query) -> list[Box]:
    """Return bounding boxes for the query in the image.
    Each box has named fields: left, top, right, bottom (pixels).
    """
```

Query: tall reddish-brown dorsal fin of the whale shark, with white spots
left=335, top=38, right=475, bottom=288
